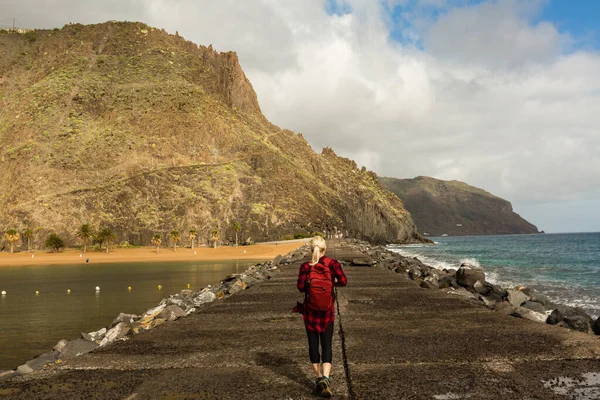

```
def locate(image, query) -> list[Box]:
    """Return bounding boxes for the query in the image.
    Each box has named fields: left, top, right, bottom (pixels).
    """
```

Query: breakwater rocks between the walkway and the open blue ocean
left=346, top=240, right=600, bottom=335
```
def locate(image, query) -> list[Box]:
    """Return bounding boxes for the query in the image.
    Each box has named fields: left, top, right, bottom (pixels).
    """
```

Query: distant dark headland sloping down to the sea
left=379, top=176, right=538, bottom=236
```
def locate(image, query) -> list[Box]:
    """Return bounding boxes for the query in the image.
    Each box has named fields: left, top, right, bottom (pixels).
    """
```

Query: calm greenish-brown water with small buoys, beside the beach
left=0, top=260, right=255, bottom=370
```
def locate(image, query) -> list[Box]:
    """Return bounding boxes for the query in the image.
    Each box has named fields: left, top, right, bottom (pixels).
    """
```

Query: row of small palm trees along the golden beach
left=4, top=221, right=241, bottom=254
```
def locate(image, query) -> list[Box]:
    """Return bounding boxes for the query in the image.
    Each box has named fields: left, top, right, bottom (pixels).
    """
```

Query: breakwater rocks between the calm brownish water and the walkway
left=0, top=245, right=309, bottom=382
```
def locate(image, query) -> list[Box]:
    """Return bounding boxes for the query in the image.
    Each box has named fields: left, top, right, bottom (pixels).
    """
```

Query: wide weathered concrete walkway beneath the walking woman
left=0, top=239, right=600, bottom=400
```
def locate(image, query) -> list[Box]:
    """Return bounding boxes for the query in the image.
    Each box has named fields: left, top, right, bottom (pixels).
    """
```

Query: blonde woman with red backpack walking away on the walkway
left=297, top=236, right=347, bottom=397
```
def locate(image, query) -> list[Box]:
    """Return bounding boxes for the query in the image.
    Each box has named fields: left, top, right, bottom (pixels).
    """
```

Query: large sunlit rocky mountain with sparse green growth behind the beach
left=0, top=22, right=421, bottom=244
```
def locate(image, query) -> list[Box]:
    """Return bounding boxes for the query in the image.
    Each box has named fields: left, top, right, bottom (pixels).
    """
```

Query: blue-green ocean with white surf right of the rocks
left=389, top=233, right=600, bottom=317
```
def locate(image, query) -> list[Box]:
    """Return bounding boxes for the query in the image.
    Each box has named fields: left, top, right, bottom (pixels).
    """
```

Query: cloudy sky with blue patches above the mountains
left=0, top=0, right=600, bottom=232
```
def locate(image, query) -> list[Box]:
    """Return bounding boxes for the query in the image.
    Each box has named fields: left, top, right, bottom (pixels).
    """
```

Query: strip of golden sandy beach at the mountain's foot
left=0, top=241, right=303, bottom=267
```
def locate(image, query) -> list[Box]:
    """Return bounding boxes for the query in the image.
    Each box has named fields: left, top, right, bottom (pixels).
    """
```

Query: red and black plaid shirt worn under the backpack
left=296, top=256, right=348, bottom=332
